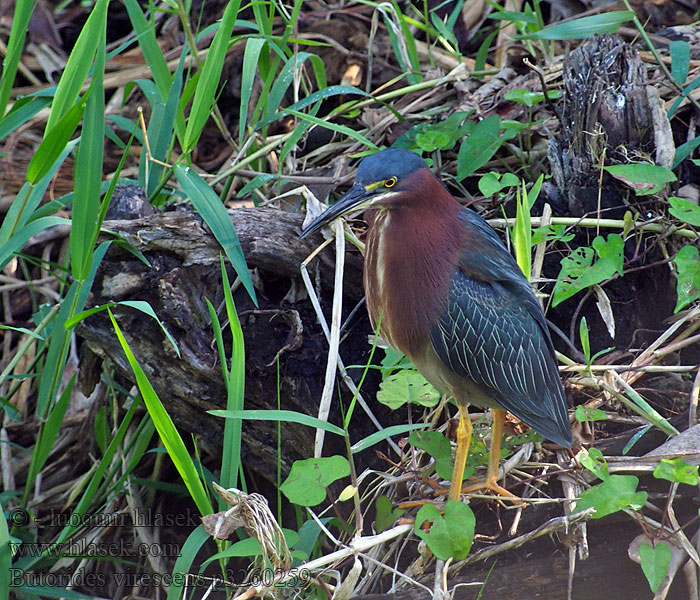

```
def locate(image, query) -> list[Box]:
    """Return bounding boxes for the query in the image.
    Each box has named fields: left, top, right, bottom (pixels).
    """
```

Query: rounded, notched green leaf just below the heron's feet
left=413, top=500, right=476, bottom=560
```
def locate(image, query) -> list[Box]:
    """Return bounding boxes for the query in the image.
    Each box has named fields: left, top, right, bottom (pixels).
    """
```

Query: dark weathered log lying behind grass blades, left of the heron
left=78, top=199, right=368, bottom=482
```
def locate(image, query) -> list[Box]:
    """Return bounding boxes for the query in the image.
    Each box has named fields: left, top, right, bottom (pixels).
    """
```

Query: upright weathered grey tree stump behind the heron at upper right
left=548, top=35, right=674, bottom=218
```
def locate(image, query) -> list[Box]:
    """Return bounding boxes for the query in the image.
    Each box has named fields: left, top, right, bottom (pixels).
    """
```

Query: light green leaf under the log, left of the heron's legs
left=280, top=456, right=350, bottom=506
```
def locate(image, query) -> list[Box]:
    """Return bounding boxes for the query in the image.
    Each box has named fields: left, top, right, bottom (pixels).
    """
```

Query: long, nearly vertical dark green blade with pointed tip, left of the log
left=70, top=22, right=107, bottom=281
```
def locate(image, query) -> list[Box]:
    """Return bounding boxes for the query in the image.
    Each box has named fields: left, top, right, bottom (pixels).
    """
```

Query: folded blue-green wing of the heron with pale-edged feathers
left=430, top=211, right=571, bottom=446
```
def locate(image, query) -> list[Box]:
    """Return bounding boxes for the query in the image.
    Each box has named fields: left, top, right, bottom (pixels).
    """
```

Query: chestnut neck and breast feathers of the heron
left=364, top=168, right=463, bottom=358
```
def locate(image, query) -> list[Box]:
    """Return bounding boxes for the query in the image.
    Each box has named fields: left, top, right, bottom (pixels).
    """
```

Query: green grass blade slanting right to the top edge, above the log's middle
left=183, top=0, right=241, bottom=154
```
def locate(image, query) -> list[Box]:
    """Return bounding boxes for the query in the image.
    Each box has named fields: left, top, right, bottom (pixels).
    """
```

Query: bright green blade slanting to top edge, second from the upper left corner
left=45, top=0, right=108, bottom=134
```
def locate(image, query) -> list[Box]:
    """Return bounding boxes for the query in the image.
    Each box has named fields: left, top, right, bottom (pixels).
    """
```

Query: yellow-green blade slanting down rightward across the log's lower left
left=108, top=309, right=213, bottom=515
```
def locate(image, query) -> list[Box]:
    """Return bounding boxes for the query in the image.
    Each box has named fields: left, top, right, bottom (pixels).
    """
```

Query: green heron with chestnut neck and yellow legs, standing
left=301, top=148, right=573, bottom=500
